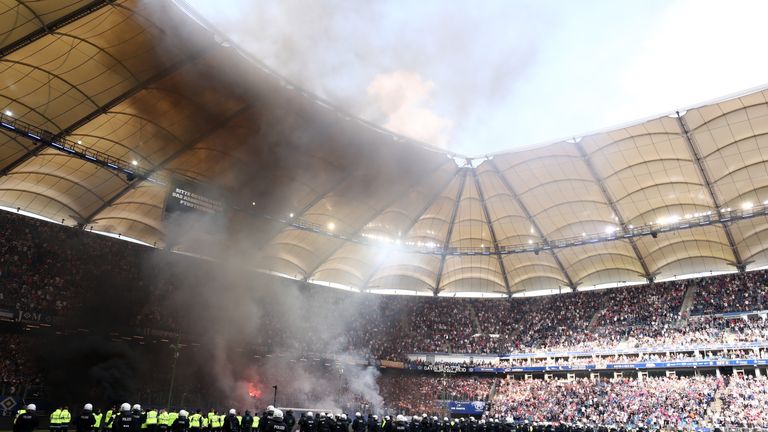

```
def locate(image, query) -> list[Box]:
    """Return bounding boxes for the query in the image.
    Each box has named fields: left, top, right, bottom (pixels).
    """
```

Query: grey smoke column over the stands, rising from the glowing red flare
left=148, top=202, right=383, bottom=411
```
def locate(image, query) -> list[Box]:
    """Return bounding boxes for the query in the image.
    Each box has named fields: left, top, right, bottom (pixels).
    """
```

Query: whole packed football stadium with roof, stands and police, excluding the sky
left=0, top=0, right=768, bottom=432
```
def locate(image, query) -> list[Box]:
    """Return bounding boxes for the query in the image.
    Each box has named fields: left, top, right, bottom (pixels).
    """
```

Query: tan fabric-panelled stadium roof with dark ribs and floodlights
left=0, top=0, right=768, bottom=294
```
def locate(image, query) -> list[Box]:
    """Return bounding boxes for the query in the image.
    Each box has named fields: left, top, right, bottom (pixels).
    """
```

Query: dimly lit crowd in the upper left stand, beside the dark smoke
left=0, top=208, right=143, bottom=314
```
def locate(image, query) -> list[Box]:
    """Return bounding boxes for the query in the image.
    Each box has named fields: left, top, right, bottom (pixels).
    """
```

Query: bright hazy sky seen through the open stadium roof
left=186, top=0, right=768, bottom=157
